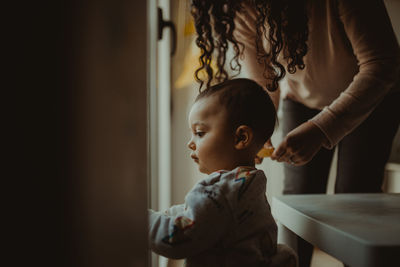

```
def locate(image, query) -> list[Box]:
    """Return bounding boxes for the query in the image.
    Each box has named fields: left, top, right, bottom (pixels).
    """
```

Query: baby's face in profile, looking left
left=188, top=96, right=237, bottom=174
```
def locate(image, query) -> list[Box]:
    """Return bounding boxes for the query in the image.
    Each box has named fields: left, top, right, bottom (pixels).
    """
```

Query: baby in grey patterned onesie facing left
left=149, top=79, right=297, bottom=267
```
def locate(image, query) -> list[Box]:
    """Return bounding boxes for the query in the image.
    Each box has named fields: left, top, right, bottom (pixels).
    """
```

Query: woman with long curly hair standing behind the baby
left=192, top=0, right=400, bottom=266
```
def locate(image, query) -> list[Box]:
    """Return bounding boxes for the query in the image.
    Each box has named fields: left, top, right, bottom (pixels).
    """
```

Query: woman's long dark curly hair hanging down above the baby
left=191, top=0, right=308, bottom=91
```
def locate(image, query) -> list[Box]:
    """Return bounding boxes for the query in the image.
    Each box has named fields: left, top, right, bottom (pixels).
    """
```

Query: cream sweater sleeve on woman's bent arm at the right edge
left=311, top=0, right=400, bottom=148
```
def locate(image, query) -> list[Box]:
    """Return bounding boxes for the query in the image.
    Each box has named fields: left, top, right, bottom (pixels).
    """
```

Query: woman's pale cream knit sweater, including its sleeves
left=235, top=0, right=400, bottom=148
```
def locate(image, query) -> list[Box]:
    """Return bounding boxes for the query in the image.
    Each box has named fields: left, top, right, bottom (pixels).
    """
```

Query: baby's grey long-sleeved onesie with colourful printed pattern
left=149, top=167, right=295, bottom=267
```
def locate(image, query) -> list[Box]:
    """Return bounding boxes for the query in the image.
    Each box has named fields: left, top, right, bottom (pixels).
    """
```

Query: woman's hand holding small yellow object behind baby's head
left=271, top=121, right=328, bottom=166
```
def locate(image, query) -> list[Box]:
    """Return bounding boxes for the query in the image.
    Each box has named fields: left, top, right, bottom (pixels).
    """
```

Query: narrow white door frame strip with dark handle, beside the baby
left=149, top=0, right=176, bottom=267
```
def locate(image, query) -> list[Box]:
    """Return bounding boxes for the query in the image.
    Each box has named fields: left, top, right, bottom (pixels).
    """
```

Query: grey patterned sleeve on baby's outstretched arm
left=149, top=180, right=232, bottom=259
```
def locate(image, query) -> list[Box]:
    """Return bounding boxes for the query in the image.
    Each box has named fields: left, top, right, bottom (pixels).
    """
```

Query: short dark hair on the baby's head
left=196, top=78, right=277, bottom=144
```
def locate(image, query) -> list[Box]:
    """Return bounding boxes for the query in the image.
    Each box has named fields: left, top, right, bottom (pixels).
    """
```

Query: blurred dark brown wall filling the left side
left=10, top=0, right=148, bottom=266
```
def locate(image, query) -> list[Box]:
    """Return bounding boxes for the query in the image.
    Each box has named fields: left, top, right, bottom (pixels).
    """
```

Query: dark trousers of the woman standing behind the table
left=282, top=92, right=400, bottom=267
